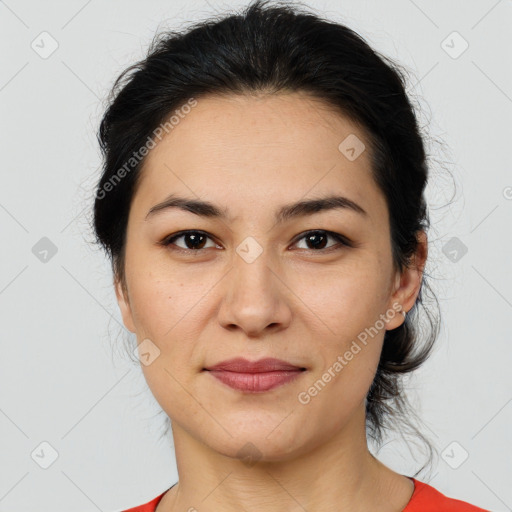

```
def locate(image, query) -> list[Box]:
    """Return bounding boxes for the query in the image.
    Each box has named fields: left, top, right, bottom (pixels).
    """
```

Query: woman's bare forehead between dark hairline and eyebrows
left=133, top=93, right=386, bottom=226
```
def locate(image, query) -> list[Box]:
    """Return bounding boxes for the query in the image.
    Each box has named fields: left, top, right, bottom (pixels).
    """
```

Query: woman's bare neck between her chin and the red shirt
left=157, top=404, right=413, bottom=512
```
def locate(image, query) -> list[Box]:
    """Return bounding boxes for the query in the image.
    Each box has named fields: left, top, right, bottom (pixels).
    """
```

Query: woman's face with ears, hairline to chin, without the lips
left=116, top=93, right=420, bottom=460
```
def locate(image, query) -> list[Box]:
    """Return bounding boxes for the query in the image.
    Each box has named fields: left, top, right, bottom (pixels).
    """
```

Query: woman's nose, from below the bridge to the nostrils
left=218, top=247, right=293, bottom=338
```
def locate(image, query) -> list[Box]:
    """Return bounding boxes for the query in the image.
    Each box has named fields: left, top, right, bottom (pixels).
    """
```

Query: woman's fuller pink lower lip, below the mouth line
left=204, top=370, right=304, bottom=393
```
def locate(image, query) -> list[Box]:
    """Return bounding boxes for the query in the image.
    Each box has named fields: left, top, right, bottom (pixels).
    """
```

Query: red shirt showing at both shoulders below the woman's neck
left=123, top=477, right=491, bottom=512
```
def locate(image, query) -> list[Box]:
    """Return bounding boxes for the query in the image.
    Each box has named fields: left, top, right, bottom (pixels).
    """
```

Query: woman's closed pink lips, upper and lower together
left=204, top=357, right=306, bottom=393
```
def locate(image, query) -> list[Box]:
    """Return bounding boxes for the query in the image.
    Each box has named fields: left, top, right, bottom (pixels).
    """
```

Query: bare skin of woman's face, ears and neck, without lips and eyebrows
left=114, top=93, right=427, bottom=512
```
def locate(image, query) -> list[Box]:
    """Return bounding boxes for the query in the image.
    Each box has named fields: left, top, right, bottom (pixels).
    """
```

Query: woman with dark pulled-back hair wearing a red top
left=94, top=2, right=490, bottom=512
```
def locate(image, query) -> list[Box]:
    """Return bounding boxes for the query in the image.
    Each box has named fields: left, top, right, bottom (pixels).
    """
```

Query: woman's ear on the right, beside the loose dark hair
left=386, top=230, right=428, bottom=331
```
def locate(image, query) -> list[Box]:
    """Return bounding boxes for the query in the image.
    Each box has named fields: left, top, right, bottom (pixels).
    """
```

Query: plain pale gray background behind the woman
left=0, top=0, right=512, bottom=512
